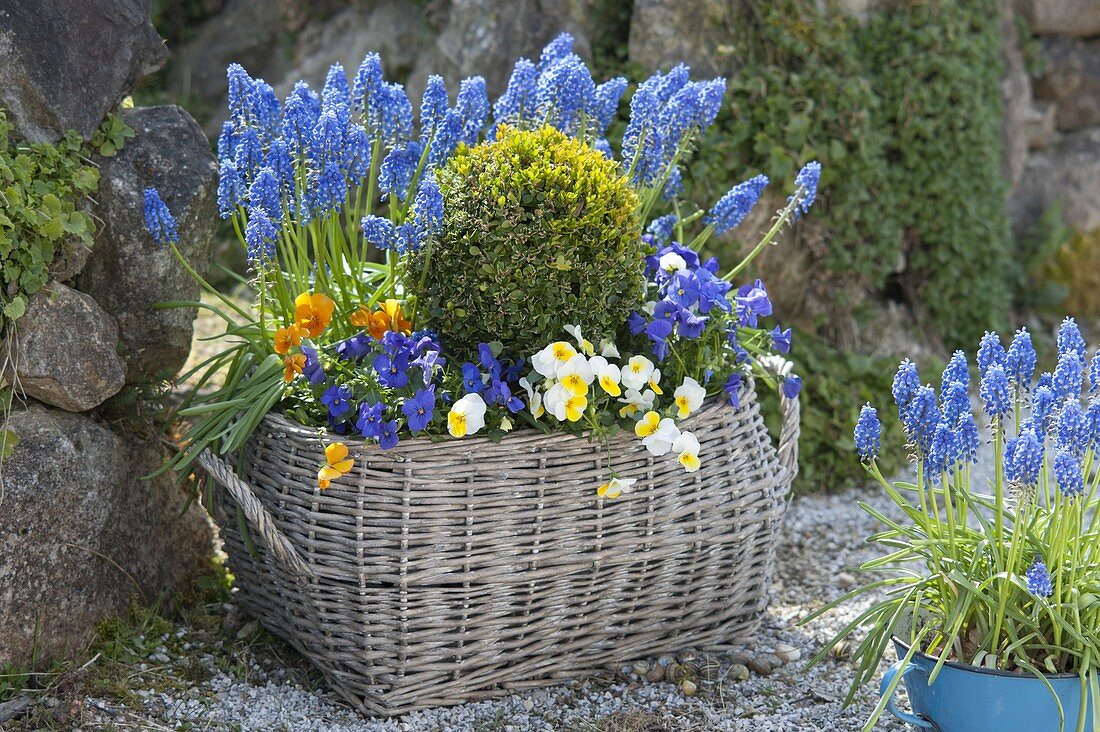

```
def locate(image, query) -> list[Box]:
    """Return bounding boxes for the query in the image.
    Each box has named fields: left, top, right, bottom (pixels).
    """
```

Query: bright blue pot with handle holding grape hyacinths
left=879, top=638, right=1092, bottom=732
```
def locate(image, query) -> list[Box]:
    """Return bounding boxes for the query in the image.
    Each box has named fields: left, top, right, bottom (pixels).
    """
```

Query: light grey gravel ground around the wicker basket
left=66, top=491, right=908, bottom=732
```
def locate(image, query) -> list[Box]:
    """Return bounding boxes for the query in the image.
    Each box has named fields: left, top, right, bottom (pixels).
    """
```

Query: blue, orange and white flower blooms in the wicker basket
left=145, top=34, right=821, bottom=498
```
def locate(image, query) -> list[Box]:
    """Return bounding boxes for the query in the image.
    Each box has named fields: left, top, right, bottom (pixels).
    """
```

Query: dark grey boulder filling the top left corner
left=0, top=0, right=167, bottom=141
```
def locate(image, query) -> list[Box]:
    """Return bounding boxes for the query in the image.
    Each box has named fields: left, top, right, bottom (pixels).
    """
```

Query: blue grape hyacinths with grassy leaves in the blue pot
left=807, top=318, right=1100, bottom=732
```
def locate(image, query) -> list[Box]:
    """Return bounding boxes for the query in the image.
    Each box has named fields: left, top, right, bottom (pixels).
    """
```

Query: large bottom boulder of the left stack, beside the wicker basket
left=0, top=405, right=212, bottom=666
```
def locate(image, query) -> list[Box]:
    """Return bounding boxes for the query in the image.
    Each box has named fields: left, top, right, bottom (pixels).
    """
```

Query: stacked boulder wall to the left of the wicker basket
left=0, top=0, right=217, bottom=667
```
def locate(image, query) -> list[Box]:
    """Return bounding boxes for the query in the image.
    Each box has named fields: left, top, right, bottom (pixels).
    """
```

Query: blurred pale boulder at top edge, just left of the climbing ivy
left=629, top=0, right=744, bottom=77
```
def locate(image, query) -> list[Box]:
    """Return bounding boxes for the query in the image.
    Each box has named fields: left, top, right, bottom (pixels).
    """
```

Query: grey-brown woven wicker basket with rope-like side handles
left=202, top=374, right=799, bottom=715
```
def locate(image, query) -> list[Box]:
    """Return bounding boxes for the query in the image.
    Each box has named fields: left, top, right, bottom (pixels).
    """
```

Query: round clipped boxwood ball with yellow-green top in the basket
left=411, top=127, right=647, bottom=356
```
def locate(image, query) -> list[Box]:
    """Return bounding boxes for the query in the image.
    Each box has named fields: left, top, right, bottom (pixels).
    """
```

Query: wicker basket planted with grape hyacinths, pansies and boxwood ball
left=146, top=34, right=821, bottom=714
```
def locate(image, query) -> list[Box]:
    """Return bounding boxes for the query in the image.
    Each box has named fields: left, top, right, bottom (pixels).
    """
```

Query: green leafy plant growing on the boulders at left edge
left=0, top=110, right=102, bottom=321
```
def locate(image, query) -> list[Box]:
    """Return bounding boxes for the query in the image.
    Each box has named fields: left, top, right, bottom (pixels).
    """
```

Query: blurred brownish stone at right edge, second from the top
left=1035, top=36, right=1100, bottom=131
